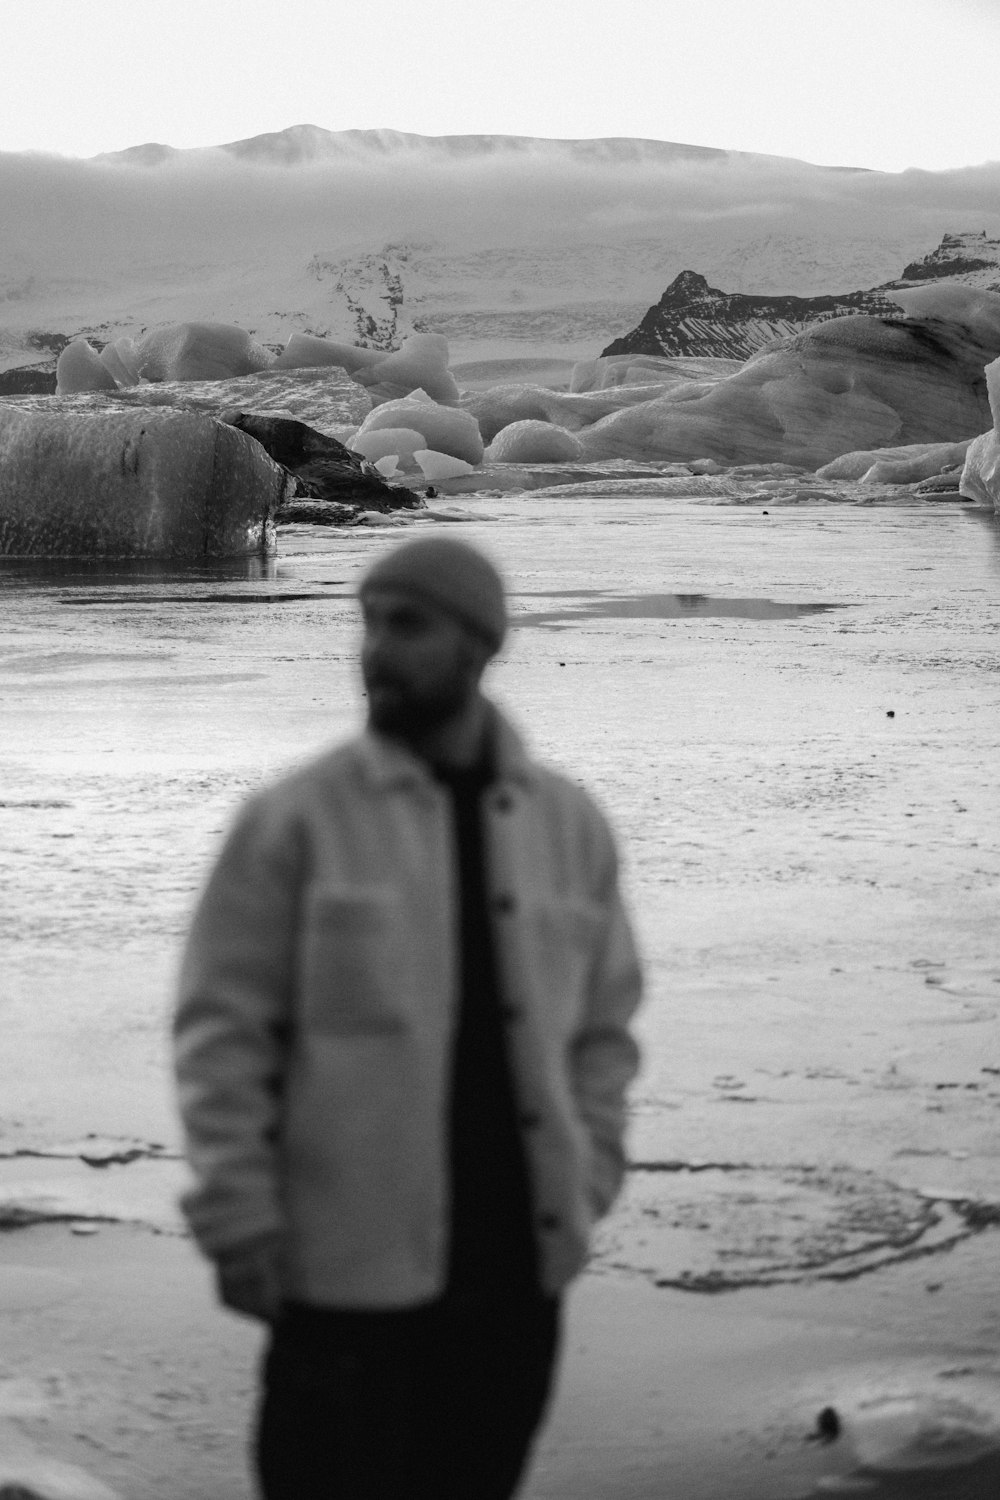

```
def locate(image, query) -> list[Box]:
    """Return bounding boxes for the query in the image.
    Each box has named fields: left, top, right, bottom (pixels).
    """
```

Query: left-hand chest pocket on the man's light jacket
left=298, top=887, right=409, bottom=1037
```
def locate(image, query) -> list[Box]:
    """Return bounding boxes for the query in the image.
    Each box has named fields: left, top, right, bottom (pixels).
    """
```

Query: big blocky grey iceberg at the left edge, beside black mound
left=0, top=407, right=288, bottom=558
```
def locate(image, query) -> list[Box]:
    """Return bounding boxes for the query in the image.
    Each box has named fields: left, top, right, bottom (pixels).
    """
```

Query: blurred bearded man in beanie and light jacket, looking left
left=175, top=537, right=639, bottom=1500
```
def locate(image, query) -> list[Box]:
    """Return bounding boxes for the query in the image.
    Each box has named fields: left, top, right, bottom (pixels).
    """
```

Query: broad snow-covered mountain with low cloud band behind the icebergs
left=0, top=126, right=1000, bottom=378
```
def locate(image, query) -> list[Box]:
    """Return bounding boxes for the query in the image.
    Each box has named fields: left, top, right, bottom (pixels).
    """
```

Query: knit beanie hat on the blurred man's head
left=358, top=537, right=507, bottom=651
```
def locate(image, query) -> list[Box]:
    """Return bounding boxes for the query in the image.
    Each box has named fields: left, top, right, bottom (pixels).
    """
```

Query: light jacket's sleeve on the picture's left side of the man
left=174, top=800, right=300, bottom=1256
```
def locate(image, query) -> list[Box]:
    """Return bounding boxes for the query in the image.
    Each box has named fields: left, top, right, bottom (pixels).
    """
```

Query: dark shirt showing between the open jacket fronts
left=435, top=762, right=541, bottom=1307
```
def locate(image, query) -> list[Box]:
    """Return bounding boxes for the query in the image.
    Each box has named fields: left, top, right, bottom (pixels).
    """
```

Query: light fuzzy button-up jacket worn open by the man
left=175, top=710, right=640, bottom=1308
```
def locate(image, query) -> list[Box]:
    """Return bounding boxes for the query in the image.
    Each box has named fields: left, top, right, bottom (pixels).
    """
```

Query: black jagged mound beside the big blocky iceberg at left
left=222, top=411, right=423, bottom=525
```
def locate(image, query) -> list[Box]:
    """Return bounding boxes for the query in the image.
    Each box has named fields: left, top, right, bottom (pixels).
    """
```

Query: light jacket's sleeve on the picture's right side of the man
left=570, top=815, right=642, bottom=1218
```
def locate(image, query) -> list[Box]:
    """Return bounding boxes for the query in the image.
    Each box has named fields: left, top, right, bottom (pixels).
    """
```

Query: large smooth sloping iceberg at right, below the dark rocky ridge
left=580, top=304, right=1000, bottom=468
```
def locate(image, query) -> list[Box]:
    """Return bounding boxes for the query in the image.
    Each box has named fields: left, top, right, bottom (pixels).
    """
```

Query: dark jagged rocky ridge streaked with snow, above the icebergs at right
left=603, top=231, right=1000, bottom=360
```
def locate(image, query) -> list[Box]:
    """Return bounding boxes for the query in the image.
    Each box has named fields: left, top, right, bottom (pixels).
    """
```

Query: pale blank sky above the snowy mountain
left=0, top=0, right=1000, bottom=173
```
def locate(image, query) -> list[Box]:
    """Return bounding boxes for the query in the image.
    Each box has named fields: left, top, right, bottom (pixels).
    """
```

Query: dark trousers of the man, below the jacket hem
left=256, top=1299, right=559, bottom=1500
